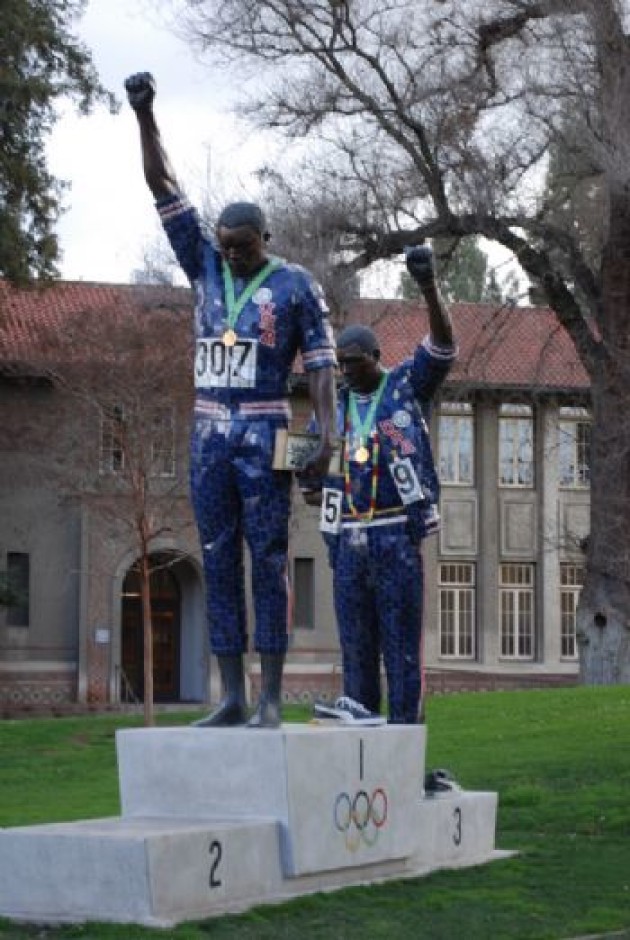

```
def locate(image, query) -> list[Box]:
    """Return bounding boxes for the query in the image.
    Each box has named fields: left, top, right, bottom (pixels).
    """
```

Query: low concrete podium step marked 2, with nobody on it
left=0, top=817, right=283, bottom=926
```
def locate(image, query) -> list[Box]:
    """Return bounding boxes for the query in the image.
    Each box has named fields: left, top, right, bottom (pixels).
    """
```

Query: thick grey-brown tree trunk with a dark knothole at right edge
left=577, top=190, right=630, bottom=685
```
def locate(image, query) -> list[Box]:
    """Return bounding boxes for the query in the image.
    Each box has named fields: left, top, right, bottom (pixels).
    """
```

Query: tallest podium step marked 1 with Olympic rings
left=116, top=725, right=426, bottom=877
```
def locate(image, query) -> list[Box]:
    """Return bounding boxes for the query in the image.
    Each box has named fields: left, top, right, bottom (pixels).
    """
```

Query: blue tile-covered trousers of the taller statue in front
left=190, top=417, right=291, bottom=655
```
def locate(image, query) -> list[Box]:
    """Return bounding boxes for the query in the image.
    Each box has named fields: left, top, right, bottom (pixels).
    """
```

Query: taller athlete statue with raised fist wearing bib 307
left=125, top=72, right=336, bottom=728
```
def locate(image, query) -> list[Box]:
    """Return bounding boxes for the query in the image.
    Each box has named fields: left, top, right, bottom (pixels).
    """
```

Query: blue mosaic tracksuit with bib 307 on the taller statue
left=157, top=196, right=336, bottom=655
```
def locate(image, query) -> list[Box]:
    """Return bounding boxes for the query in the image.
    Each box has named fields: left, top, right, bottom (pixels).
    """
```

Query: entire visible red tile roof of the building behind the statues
left=0, top=279, right=590, bottom=390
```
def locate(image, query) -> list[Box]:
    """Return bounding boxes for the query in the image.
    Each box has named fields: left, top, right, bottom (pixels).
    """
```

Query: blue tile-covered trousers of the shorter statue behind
left=331, top=523, right=423, bottom=724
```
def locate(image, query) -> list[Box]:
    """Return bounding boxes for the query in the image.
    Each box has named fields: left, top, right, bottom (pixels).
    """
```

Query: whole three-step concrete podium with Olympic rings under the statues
left=0, top=724, right=511, bottom=926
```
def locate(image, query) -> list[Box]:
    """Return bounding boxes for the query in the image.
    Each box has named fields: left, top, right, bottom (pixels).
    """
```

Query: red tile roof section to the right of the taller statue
left=350, top=300, right=590, bottom=390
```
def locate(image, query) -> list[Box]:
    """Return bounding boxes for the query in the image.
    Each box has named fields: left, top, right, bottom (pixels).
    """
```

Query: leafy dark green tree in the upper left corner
left=0, top=0, right=116, bottom=283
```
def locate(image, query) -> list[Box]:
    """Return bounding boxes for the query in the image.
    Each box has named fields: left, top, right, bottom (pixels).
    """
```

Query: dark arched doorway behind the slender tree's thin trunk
left=120, top=557, right=182, bottom=702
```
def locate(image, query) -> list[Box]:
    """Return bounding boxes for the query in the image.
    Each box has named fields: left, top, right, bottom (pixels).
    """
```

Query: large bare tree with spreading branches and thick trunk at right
left=173, top=0, right=630, bottom=682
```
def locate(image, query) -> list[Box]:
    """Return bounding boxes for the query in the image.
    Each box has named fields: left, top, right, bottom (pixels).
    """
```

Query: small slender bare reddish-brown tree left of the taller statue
left=0, top=288, right=194, bottom=725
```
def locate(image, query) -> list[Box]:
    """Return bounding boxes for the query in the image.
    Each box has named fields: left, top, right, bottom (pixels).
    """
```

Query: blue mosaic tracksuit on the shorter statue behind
left=322, top=338, right=455, bottom=724
